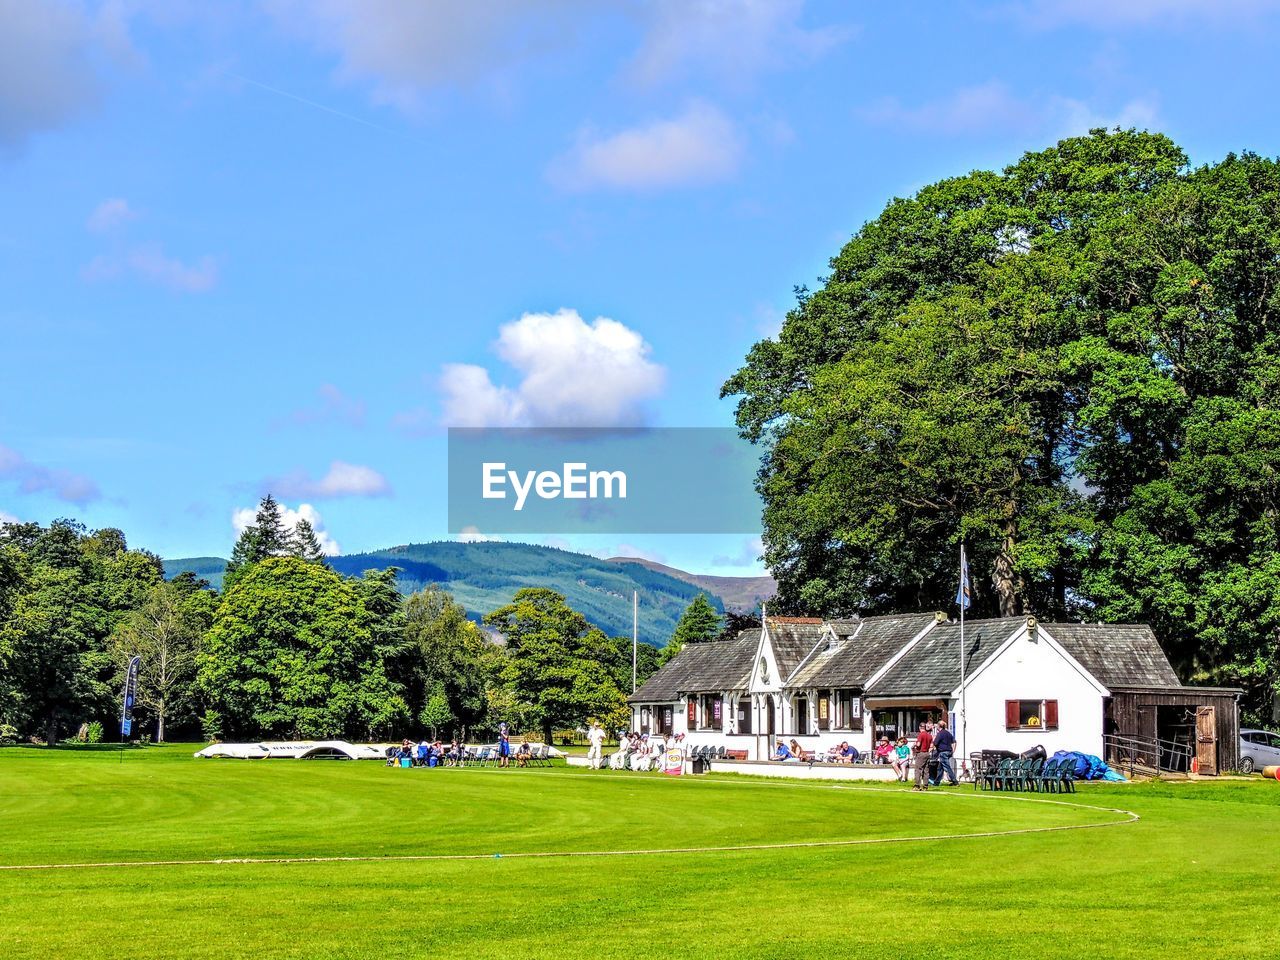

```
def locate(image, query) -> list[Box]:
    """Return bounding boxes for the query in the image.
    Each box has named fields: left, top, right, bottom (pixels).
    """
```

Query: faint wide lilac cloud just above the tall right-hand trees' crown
left=860, top=81, right=1156, bottom=137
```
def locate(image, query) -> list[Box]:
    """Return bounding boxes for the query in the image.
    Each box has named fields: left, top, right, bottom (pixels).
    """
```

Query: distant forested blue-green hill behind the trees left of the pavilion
left=164, top=541, right=768, bottom=646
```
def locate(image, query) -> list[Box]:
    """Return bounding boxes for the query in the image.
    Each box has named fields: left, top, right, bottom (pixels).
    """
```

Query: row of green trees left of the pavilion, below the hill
left=0, top=497, right=675, bottom=744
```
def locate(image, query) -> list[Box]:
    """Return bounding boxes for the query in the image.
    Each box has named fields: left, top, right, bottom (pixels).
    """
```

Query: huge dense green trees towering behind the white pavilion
left=722, top=131, right=1280, bottom=719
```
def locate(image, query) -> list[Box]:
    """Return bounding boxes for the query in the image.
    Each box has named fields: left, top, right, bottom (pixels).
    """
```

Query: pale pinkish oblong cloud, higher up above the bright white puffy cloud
left=548, top=101, right=742, bottom=191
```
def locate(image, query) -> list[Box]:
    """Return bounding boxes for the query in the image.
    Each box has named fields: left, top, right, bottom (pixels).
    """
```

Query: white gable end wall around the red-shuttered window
left=952, top=628, right=1102, bottom=755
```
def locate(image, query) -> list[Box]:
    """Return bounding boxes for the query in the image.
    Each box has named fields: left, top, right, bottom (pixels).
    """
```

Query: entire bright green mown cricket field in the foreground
left=0, top=746, right=1280, bottom=960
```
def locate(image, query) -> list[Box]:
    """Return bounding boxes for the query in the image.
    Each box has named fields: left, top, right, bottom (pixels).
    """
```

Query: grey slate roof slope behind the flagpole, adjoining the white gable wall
left=867, top=617, right=1018, bottom=696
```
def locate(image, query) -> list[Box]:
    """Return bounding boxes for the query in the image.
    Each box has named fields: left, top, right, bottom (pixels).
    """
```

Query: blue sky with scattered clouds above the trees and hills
left=0, top=0, right=1280, bottom=575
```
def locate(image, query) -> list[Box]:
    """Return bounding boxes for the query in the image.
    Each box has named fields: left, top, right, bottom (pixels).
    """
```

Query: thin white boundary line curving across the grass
left=0, top=771, right=1142, bottom=872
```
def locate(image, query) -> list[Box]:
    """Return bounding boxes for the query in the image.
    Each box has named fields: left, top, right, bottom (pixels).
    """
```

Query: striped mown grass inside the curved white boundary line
left=0, top=755, right=1098, bottom=865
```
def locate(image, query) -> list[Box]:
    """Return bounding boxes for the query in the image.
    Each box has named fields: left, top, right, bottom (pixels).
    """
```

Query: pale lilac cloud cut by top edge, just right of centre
left=626, top=0, right=851, bottom=86
